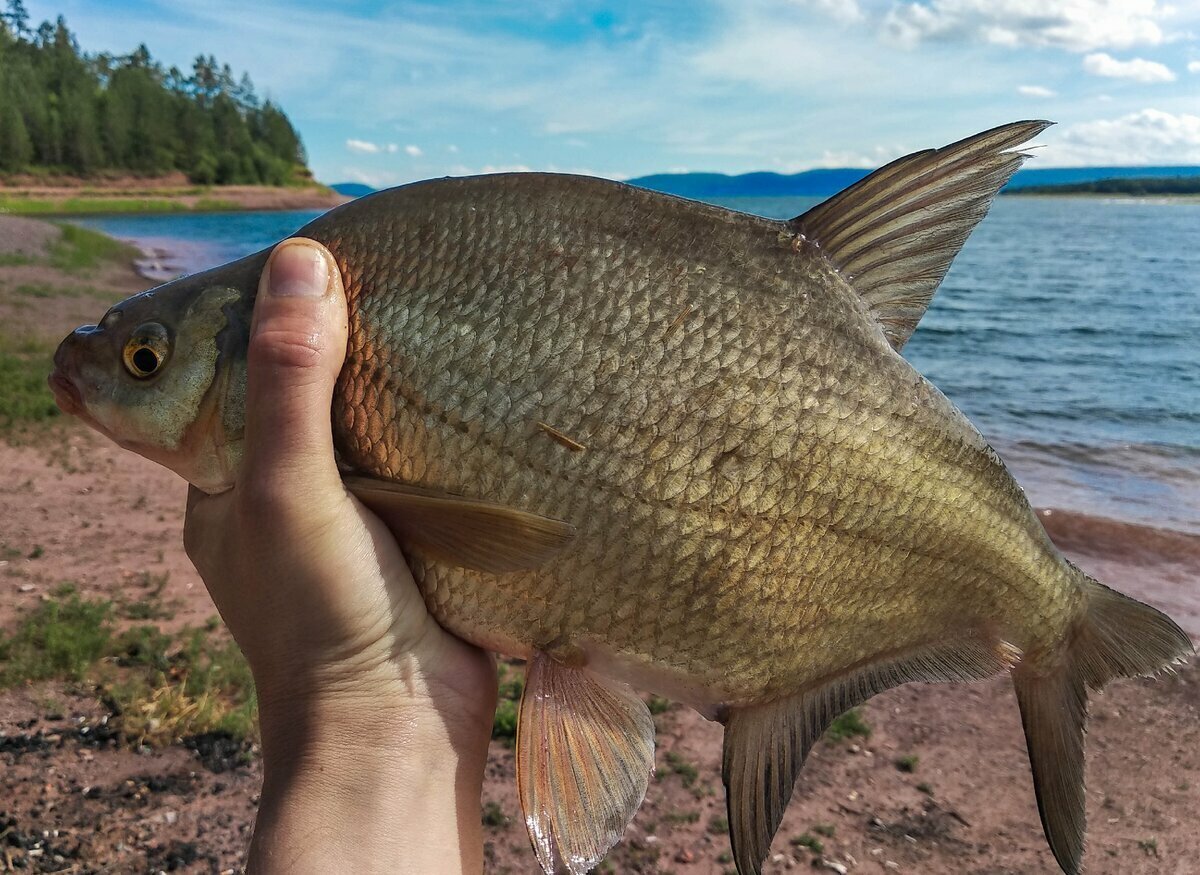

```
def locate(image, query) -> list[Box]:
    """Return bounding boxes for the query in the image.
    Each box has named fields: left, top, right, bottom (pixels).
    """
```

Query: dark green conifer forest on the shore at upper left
left=0, top=0, right=311, bottom=185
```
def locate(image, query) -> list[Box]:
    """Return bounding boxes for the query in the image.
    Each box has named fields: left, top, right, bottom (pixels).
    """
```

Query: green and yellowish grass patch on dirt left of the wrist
left=0, top=585, right=258, bottom=745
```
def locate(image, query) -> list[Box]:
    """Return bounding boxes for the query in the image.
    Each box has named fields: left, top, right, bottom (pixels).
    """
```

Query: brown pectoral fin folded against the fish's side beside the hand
left=343, top=477, right=575, bottom=574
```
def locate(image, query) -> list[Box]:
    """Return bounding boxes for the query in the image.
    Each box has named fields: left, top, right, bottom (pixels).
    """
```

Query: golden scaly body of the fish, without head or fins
left=309, top=174, right=1079, bottom=712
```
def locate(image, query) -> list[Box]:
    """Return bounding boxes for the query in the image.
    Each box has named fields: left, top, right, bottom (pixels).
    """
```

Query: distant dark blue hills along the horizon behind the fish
left=330, top=167, right=1200, bottom=200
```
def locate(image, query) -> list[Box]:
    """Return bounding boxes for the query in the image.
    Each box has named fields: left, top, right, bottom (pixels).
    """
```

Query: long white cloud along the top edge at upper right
left=883, top=0, right=1174, bottom=52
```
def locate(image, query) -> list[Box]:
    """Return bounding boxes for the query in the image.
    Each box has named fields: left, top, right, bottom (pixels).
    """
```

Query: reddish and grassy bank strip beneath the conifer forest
left=0, top=176, right=350, bottom=216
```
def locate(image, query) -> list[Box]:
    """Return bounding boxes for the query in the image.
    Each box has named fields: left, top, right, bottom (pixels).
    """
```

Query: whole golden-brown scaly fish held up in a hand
left=50, top=121, right=1193, bottom=875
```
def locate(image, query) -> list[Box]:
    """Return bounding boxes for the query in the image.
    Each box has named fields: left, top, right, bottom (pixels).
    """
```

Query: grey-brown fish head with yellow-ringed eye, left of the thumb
left=49, top=252, right=268, bottom=492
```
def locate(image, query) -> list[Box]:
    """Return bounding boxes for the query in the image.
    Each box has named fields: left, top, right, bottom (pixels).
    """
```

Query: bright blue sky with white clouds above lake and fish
left=26, top=0, right=1200, bottom=186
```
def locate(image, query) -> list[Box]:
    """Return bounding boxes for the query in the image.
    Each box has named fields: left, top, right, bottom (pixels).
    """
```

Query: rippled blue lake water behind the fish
left=72, top=198, right=1200, bottom=534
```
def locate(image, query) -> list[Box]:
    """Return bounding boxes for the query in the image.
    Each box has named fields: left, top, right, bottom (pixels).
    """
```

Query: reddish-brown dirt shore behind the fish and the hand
left=0, top=217, right=1200, bottom=875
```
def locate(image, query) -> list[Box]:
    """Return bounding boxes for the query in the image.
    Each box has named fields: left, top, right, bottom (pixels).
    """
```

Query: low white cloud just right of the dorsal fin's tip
left=1038, top=109, right=1200, bottom=167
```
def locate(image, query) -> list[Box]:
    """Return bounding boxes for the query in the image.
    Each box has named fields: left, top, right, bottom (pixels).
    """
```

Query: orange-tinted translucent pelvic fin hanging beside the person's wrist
left=516, top=653, right=654, bottom=875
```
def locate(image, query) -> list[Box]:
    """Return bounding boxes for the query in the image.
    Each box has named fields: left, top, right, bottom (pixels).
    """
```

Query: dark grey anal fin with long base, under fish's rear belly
left=721, top=637, right=1019, bottom=875
